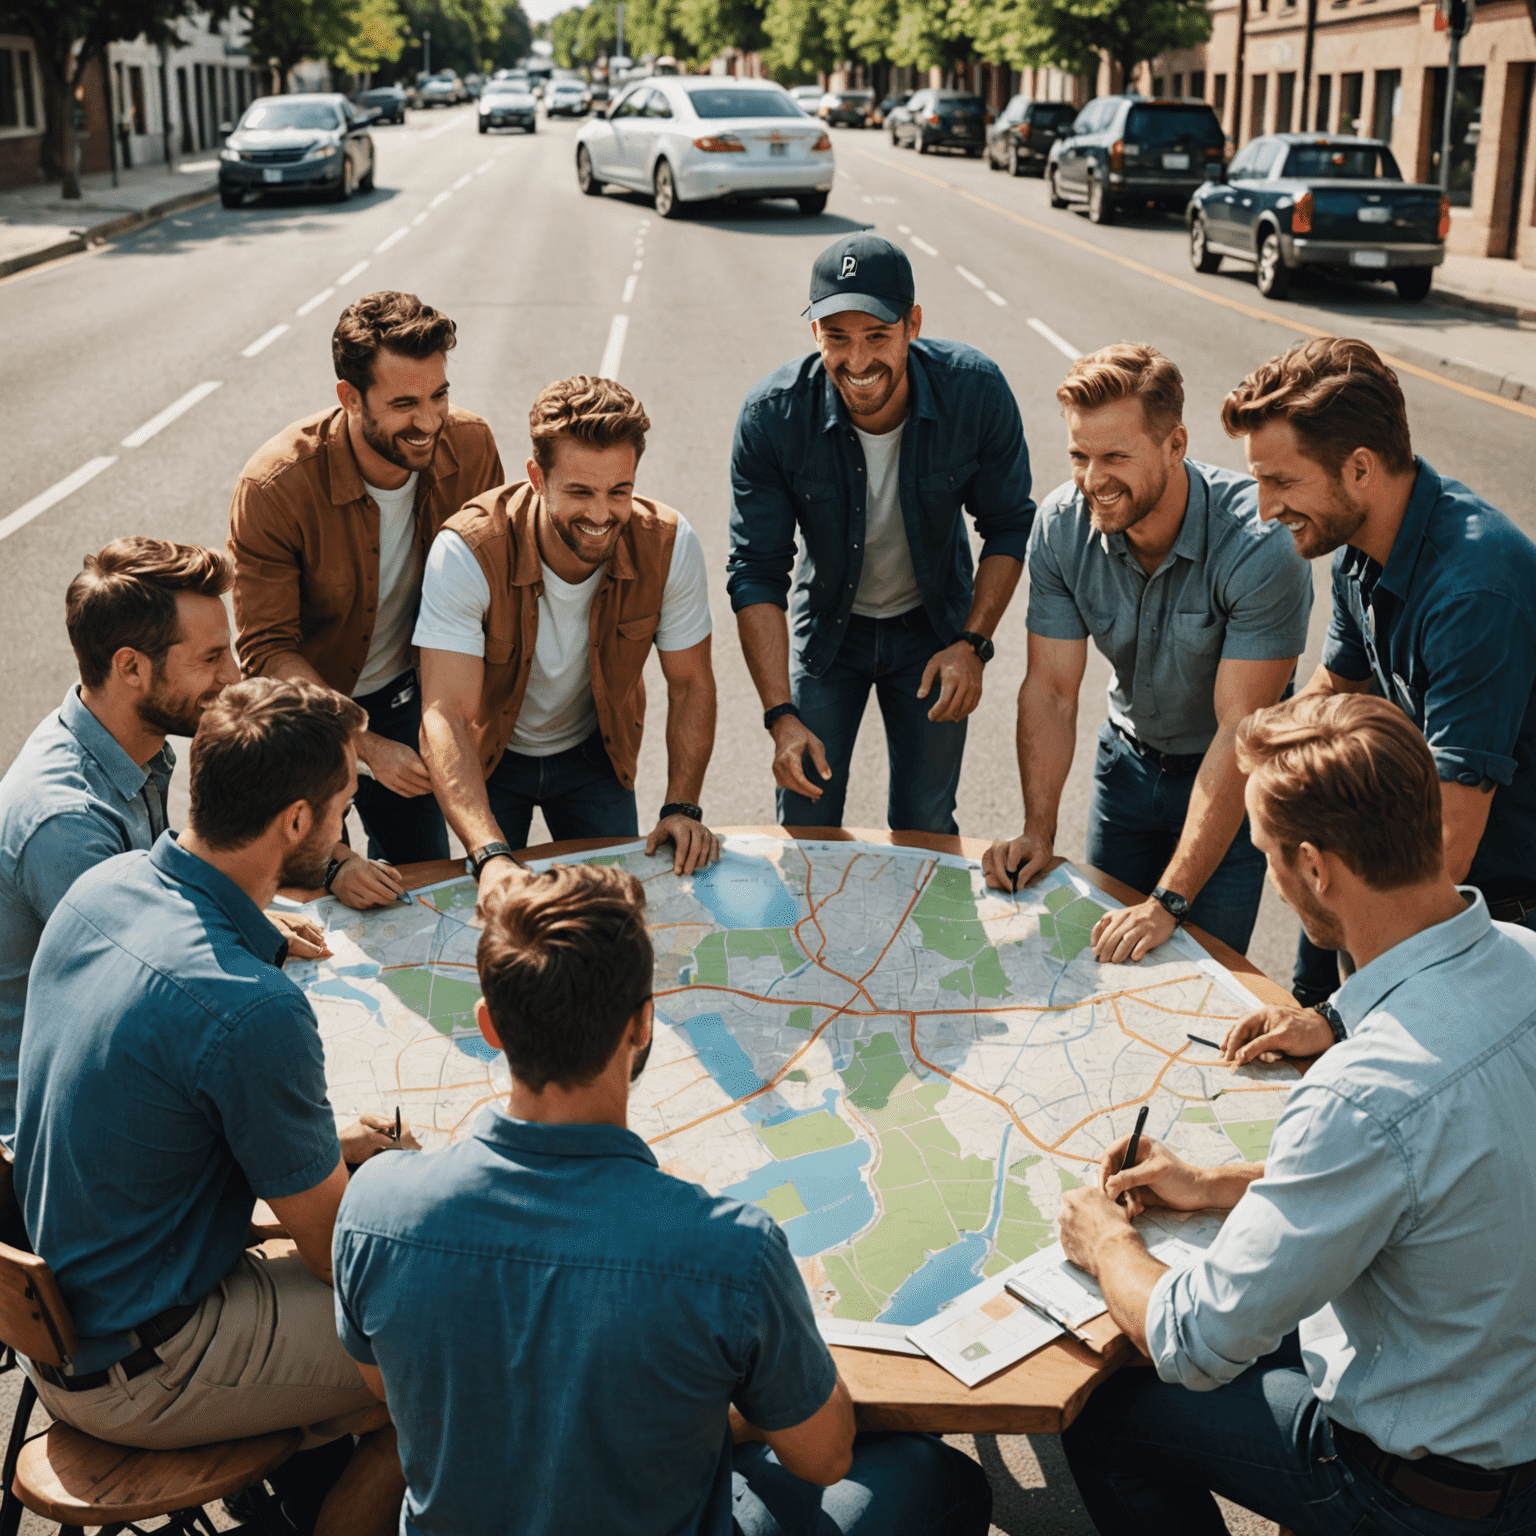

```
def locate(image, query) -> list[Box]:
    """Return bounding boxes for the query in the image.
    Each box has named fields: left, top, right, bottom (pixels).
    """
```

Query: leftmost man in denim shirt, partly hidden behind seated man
left=0, top=539, right=240, bottom=1146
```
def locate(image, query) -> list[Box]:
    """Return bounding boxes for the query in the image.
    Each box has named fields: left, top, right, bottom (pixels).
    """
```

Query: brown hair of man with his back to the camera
left=476, top=865, right=654, bottom=1094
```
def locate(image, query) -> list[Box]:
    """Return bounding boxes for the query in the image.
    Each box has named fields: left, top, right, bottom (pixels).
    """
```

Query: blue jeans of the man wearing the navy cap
left=779, top=608, right=966, bottom=834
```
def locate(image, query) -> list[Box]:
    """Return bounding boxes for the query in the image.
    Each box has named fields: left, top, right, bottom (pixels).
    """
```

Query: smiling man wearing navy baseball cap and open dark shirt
left=728, top=230, right=1035, bottom=833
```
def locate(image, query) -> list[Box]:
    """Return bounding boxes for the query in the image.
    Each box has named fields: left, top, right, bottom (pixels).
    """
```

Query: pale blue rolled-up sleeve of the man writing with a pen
left=1146, top=1083, right=1410, bottom=1392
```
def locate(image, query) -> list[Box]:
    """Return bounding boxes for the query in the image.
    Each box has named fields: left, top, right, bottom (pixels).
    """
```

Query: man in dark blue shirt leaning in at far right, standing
left=1221, top=336, right=1536, bottom=1019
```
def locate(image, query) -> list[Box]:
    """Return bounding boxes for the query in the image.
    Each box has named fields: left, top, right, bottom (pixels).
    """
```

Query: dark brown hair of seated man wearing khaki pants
left=189, top=677, right=369, bottom=849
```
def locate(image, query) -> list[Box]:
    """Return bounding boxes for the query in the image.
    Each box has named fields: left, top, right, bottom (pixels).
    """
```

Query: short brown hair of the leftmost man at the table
left=65, top=536, right=235, bottom=688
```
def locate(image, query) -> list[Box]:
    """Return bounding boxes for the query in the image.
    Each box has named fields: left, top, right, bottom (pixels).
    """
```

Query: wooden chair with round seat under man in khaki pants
left=0, top=1157, right=304, bottom=1536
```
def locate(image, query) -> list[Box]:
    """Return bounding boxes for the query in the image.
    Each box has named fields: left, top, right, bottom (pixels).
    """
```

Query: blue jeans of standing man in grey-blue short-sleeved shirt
left=1087, top=720, right=1264, bottom=954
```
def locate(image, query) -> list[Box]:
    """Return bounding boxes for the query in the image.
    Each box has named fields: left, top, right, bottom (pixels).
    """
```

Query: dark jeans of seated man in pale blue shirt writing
left=1061, top=1335, right=1536, bottom=1536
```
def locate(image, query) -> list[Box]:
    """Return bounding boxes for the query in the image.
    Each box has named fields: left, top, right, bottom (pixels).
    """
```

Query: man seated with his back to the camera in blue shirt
left=335, top=866, right=992, bottom=1536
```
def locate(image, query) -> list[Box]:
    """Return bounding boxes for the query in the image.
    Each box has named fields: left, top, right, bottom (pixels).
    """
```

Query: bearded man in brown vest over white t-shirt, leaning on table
left=415, top=373, right=720, bottom=891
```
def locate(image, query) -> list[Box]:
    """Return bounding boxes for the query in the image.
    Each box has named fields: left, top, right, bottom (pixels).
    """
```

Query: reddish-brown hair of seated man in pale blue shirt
left=1238, top=693, right=1442, bottom=891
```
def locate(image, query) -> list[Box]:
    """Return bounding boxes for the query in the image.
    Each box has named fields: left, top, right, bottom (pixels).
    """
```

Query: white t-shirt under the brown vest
left=415, top=516, right=714, bottom=757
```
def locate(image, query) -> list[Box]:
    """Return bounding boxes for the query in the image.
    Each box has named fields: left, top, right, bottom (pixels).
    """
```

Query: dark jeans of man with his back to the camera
left=731, top=1435, right=992, bottom=1536
